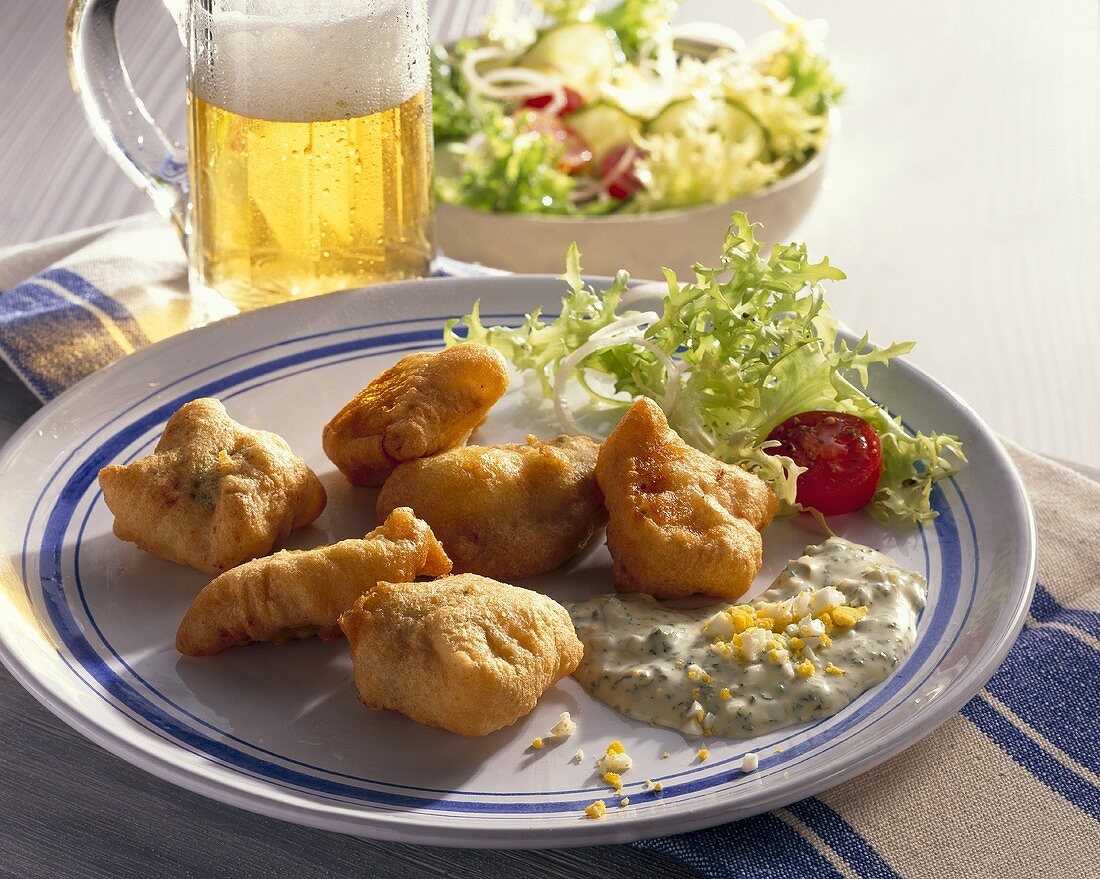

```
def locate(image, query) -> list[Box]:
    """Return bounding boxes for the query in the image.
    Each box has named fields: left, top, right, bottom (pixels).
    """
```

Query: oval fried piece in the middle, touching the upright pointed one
left=377, top=436, right=607, bottom=580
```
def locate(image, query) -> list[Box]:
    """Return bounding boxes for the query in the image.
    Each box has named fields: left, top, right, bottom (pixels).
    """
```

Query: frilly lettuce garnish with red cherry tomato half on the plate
left=444, top=213, right=966, bottom=523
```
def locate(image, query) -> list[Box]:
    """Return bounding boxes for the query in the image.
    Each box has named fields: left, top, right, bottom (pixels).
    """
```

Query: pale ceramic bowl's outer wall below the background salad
left=436, top=139, right=837, bottom=278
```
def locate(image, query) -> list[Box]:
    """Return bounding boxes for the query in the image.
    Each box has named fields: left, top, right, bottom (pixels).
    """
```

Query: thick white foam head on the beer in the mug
left=190, top=0, right=430, bottom=122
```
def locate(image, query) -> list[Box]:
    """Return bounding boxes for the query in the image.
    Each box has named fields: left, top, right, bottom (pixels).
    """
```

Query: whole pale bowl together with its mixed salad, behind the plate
left=432, top=0, right=844, bottom=277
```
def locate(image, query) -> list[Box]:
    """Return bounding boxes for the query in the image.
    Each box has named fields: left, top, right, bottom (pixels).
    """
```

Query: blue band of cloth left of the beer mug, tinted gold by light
left=0, top=283, right=125, bottom=399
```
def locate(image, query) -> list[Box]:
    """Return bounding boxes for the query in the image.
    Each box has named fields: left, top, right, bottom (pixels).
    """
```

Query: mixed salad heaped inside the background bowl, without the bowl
left=432, top=0, right=843, bottom=216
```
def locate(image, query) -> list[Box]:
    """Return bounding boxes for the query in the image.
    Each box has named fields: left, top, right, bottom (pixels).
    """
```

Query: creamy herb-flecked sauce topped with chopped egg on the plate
left=569, top=537, right=925, bottom=738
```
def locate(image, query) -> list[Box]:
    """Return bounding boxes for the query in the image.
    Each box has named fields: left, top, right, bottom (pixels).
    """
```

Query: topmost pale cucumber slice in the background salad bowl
left=518, top=21, right=623, bottom=100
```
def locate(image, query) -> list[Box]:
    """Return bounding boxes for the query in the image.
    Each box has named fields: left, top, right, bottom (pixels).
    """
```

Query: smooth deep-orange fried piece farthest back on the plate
left=323, top=344, right=508, bottom=485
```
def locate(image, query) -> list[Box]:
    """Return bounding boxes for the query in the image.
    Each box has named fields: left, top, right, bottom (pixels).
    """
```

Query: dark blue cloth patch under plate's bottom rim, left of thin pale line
left=634, top=814, right=842, bottom=879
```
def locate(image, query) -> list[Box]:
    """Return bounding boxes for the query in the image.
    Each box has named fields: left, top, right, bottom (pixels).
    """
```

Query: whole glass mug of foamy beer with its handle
left=68, top=0, right=435, bottom=310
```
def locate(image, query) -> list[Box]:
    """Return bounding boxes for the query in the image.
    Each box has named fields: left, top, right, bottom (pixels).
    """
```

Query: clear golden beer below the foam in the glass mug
left=188, top=89, right=433, bottom=310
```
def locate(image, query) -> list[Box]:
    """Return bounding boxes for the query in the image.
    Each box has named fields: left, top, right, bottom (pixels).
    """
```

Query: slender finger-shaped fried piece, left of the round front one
left=176, top=509, right=451, bottom=656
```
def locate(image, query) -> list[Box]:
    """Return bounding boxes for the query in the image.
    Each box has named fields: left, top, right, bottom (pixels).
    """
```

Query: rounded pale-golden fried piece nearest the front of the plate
left=340, top=574, right=584, bottom=736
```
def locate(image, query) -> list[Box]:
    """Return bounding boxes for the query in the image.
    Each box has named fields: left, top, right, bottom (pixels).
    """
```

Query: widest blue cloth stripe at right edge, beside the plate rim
left=986, top=627, right=1100, bottom=772
